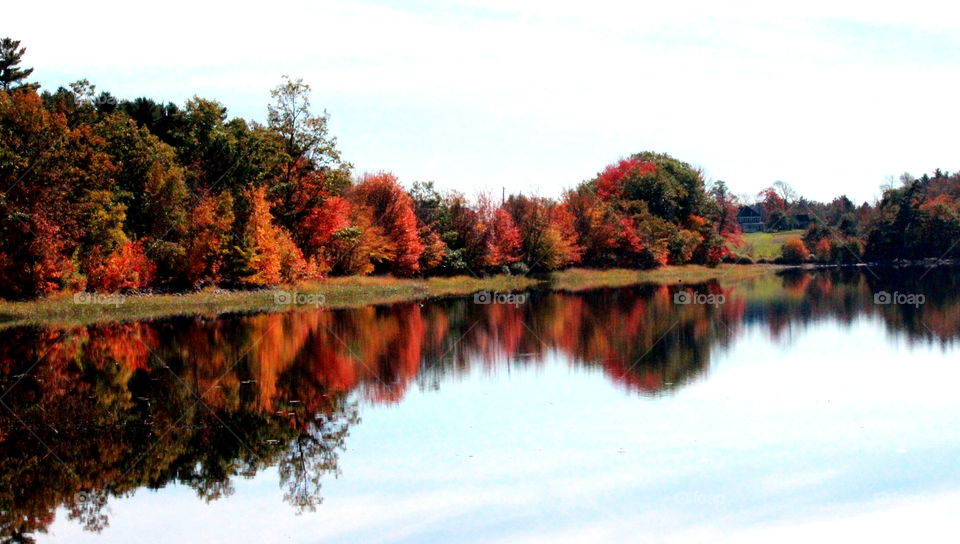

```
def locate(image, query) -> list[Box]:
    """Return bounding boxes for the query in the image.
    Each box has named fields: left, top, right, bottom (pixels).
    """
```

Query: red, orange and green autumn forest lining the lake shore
left=0, top=38, right=960, bottom=299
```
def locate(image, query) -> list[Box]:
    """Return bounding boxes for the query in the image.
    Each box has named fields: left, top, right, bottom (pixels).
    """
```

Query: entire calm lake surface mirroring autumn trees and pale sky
left=0, top=270, right=960, bottom=543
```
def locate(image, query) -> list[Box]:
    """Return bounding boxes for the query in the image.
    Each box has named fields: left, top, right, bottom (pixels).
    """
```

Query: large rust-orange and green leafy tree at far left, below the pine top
left=0, top=89, right=116, bottom=297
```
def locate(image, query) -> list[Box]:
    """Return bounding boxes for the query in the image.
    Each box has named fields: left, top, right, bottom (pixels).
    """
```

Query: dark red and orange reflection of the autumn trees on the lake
left=0, top=270, right=960, bottom=541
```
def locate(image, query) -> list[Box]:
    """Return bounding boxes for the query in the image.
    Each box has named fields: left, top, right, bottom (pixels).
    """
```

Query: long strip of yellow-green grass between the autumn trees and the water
left=0, top=264, right=782, bottom=327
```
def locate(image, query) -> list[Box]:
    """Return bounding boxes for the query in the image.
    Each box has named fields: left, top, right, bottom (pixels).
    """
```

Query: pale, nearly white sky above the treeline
left=9, top=0, right=960, bottom=201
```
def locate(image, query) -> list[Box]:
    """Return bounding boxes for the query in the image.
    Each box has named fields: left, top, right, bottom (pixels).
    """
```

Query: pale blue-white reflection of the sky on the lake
left=51, top=320, right=960, bottom=542
